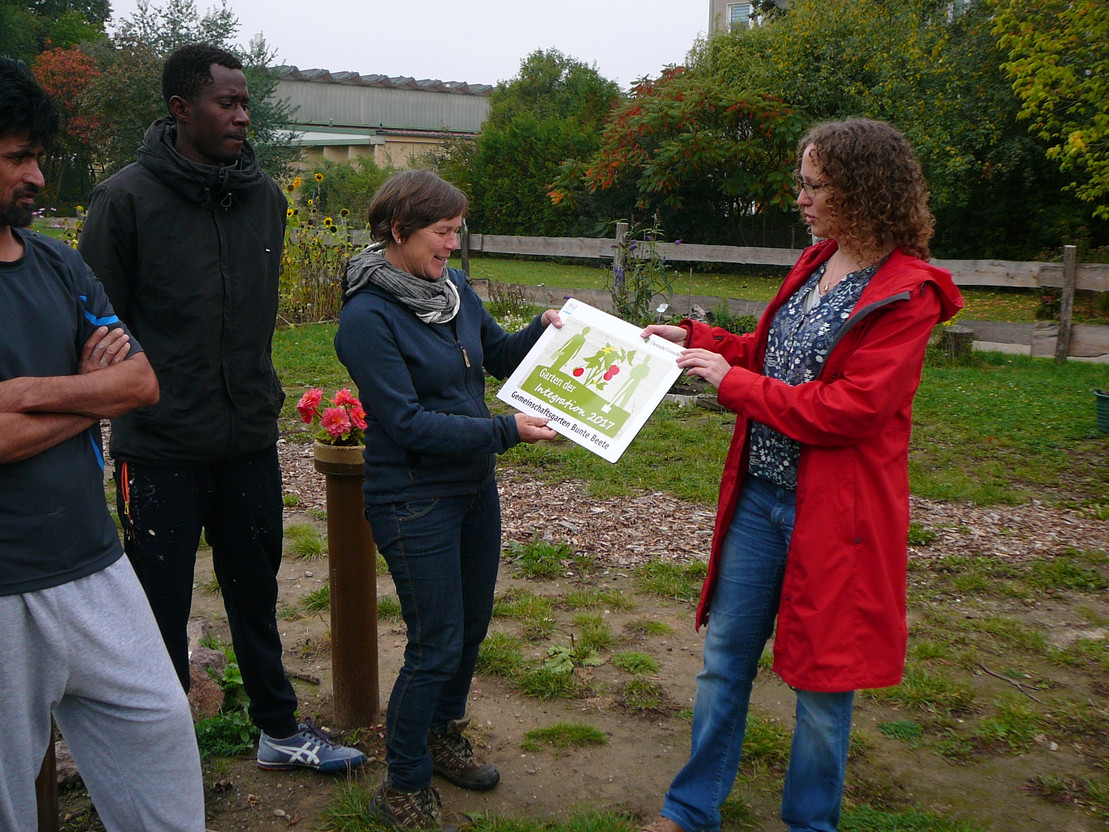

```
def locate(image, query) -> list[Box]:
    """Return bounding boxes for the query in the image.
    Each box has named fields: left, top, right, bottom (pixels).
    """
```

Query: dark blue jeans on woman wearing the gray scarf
left=366, top=477, right=500, bottom=791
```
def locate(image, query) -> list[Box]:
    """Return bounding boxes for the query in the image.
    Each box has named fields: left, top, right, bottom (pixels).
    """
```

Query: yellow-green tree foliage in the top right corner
left=995, top=0, right=1109, bottom=220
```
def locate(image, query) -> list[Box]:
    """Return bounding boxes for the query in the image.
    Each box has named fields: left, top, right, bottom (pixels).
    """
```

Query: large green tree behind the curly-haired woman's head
left=691, top=0, right=1090, bottom=260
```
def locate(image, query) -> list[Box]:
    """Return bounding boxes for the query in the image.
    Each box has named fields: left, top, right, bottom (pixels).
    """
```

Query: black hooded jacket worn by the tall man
left=79, top=119, right=286, bottom=466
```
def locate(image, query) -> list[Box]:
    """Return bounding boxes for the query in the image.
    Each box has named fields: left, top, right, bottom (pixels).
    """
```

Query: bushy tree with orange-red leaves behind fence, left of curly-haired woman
left=551, top=68, right=805, bottom=245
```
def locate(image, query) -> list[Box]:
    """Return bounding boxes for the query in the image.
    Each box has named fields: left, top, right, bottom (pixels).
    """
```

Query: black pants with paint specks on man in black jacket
left=115, top=446, right=296, bottom=737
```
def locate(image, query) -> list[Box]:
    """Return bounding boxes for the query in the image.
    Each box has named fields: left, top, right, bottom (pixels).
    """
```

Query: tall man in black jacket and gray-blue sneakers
left=80, top=44, right=366, bottom=771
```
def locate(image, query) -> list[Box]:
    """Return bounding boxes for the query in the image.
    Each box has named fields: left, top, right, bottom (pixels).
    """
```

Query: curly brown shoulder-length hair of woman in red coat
left=797, top=119, right=936, bottom=260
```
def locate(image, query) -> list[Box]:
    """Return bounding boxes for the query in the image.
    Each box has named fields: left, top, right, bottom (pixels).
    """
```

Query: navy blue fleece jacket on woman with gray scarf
left=335, top=268, right=543, bottom=505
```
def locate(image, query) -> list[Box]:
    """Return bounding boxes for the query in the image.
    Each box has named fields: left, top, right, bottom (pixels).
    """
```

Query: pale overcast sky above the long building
left=110, top=0, right=709, bottom=88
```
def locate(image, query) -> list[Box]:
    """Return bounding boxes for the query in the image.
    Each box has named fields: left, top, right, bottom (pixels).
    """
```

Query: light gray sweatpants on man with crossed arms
left=0, top=557, right=204, bottom=832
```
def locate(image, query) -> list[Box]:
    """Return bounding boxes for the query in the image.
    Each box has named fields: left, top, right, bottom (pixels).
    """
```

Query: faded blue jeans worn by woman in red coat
left=662, top=477, right=854, bottom=832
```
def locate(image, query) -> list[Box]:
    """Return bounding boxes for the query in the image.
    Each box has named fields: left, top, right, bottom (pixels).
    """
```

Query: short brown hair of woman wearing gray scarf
left=369, top=170, right=469, bottom=243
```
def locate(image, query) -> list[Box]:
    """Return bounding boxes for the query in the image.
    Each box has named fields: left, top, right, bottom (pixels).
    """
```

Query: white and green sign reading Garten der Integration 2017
left=497, top=297, right=682, bottom=463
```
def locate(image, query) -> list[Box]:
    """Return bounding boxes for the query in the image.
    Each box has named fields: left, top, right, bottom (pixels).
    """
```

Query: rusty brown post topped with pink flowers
left=313, top=443, right=380, bottom=729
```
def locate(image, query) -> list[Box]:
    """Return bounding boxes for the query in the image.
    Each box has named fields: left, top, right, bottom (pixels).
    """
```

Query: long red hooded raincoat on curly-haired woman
left=682, top=241, right=963, bottom=692
